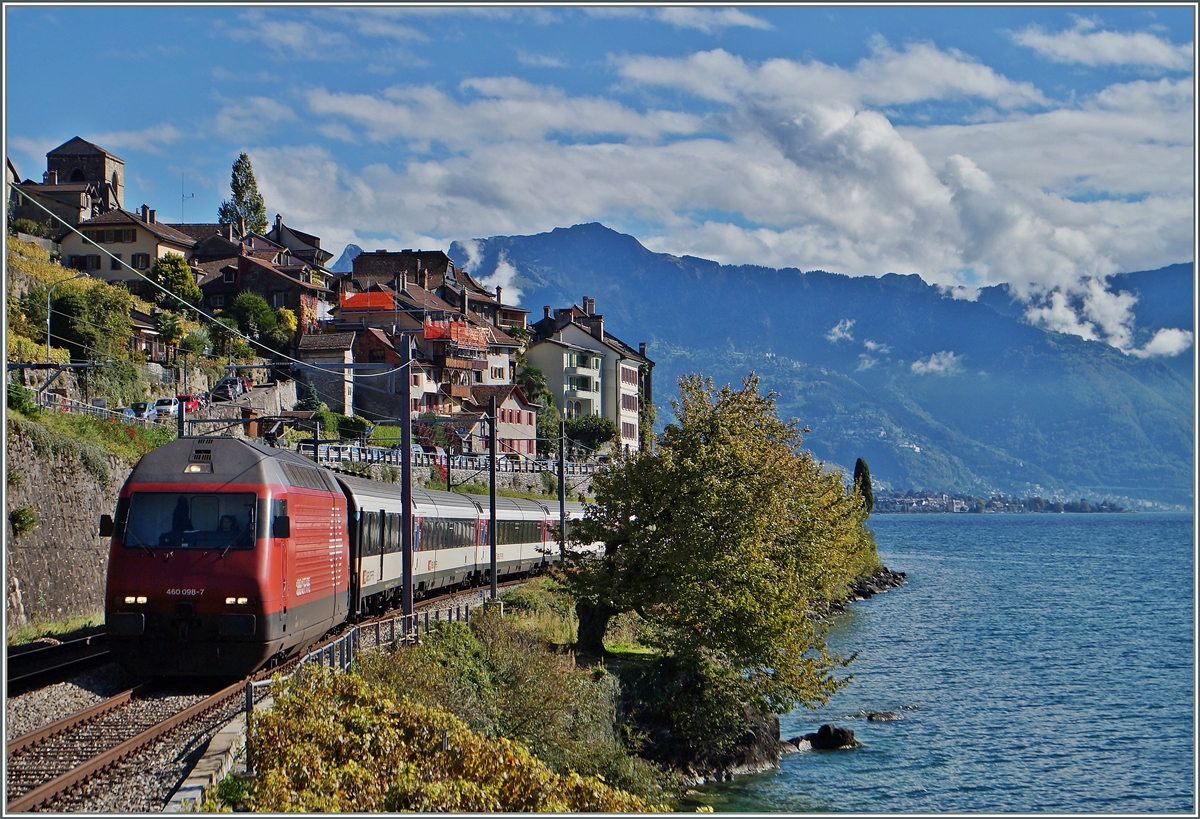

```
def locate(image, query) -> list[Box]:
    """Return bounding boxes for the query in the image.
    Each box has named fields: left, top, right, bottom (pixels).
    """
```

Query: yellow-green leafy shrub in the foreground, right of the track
left=245, top=671, right=666, bottom=812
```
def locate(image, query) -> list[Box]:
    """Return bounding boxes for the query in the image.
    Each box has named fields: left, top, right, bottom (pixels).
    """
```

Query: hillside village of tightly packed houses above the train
left=6, top=137, right=654, bottom=458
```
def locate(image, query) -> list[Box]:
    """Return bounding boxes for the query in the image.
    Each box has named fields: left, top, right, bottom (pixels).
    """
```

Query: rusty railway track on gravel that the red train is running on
left=5, top=580, right=522, bottom=813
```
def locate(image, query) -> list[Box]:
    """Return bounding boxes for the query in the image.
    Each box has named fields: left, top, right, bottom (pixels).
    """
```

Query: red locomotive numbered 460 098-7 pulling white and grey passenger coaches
left=101, top=437, right=583, bottom=677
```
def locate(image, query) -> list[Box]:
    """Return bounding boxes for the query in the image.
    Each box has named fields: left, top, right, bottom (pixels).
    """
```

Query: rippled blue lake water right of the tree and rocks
left=704, top=513, right=1196, bottom=813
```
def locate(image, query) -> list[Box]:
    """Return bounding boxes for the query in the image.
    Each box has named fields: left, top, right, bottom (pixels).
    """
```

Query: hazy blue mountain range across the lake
left=398, top=223, right=1194, bottom=508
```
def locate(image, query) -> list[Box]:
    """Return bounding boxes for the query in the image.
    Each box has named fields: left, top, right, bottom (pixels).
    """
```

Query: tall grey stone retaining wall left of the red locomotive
left=5, top=424, right=133, bottom=628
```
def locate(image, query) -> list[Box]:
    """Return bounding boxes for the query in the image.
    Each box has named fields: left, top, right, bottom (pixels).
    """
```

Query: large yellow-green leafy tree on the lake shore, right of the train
left=556, top=376, right=877, bottom=745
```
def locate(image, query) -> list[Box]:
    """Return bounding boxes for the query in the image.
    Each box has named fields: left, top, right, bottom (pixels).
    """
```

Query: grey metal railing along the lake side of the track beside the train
left=246, top=592, right=492, bottom=776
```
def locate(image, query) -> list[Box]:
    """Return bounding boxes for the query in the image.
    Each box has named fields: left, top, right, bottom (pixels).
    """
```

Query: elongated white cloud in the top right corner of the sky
left=1013, top=19, right=1193, bottom=71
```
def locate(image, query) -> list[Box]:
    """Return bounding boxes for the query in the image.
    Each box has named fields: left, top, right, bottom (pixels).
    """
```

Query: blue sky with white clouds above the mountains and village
left=5, top=5, right=1195, bottom=357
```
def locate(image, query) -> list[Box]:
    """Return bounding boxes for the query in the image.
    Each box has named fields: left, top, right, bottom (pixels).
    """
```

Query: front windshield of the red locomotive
left=124, top=492, right=256, bottom=550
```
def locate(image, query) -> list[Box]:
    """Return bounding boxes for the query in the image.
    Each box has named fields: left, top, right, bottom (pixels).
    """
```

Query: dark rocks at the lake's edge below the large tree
left=676, top=567, right=908, bottom=787
